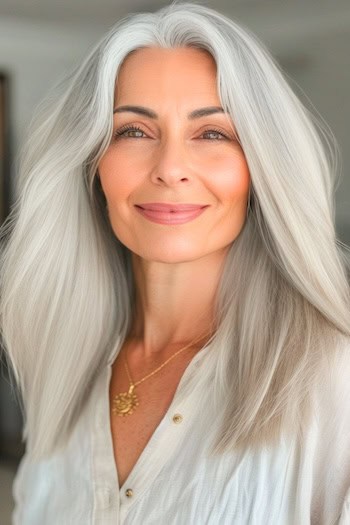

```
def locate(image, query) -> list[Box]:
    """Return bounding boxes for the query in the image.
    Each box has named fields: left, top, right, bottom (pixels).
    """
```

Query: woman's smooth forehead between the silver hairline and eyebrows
left=115, top=47, right=217, bottom=100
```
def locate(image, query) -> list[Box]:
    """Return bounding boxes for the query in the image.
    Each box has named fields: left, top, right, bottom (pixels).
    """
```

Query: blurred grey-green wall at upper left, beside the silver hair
left=0, top=13, right=103, bottom=203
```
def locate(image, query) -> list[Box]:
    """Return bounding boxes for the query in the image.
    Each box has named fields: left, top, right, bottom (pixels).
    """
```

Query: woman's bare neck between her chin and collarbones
left=128, top=251, right=226, bottom=357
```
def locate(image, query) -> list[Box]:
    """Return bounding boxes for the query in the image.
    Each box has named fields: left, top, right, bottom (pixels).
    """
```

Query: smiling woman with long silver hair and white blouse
left=1, top=3, right=350, bottom=525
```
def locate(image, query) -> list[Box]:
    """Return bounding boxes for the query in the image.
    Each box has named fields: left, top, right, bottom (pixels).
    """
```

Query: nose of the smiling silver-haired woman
left=151, top=138, right=192, bottom=186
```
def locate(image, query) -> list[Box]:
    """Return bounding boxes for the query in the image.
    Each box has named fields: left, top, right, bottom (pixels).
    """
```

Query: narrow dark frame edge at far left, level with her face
left=0, top=71, right=10, bottom=224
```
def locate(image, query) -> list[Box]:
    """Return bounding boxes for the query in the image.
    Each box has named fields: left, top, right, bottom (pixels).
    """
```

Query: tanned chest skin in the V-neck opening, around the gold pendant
left=109, top=348, right=193, bottom=487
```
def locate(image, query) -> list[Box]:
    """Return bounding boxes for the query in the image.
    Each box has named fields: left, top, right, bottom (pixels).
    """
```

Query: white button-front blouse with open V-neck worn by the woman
left=13, top=341, right=350, bottom=525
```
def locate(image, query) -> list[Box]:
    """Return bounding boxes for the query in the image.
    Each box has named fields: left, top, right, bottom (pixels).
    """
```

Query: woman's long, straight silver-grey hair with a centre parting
left=0, top=2, right=350, bottom=458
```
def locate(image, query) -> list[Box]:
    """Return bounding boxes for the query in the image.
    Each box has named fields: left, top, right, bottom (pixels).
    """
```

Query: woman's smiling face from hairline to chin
left=98, top=48, right=250, bottom=263
